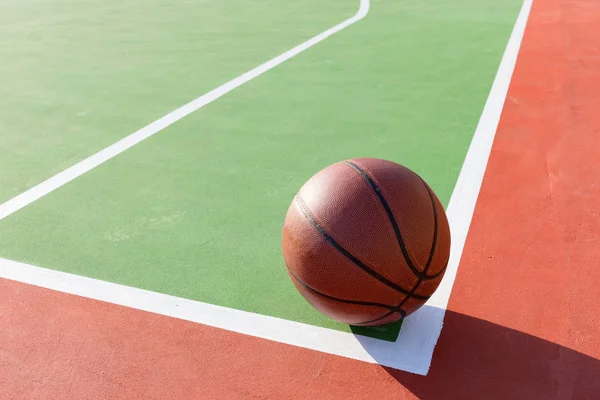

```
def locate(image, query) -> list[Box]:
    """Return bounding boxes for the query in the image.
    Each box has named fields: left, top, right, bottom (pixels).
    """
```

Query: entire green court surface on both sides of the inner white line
left=0, top=0, right=521, bottom=338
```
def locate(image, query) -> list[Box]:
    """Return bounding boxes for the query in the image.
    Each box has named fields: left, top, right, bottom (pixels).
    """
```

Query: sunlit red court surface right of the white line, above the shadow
left=451, top=0, right=600, bottom=362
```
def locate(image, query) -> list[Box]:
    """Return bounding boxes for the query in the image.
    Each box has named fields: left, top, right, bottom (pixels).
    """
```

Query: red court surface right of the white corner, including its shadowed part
left=390, top=0, right=600, bottom=399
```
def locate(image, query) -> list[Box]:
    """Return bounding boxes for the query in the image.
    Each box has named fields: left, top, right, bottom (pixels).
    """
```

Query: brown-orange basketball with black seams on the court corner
left=282, top=158, right=450, bottom=325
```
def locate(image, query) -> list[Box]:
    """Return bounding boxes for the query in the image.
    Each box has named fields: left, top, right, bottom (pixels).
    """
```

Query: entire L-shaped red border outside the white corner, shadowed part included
left=0, top=0, right=600, bottom=400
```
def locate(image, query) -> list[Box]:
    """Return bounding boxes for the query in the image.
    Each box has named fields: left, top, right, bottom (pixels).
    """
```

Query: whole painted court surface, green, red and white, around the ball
left=0, top=0, right=600, bottom=399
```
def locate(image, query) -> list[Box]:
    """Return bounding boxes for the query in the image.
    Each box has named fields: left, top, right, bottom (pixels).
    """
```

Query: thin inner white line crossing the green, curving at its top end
left=0, top=0, right=370, bottom=220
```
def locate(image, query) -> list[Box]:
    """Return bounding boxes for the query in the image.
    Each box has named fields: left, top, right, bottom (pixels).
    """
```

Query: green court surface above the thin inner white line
left=0, top=0, right=359, bottom=203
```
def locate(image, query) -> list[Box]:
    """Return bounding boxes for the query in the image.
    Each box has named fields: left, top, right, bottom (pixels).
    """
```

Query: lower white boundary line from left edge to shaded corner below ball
left=0, top=259, right=432, bottom=375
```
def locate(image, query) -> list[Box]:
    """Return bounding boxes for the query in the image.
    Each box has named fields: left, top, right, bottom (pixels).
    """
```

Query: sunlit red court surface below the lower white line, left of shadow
left=0, top=279, right=418, bottom=400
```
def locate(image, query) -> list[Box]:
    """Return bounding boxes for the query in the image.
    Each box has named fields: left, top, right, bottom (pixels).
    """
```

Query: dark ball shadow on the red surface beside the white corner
left=356, top=311, right=600, bottom=400
